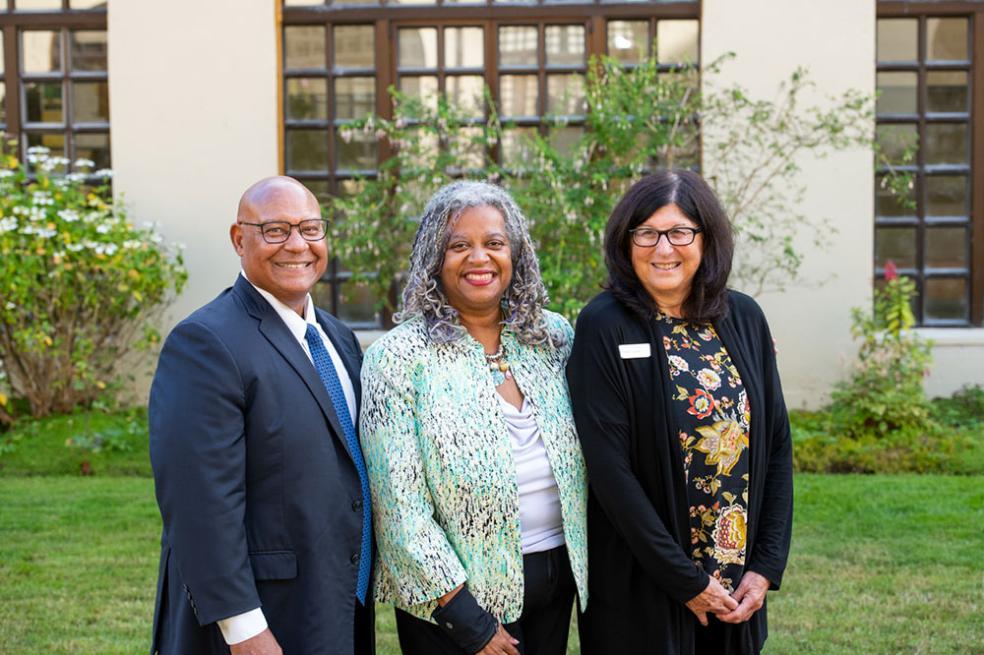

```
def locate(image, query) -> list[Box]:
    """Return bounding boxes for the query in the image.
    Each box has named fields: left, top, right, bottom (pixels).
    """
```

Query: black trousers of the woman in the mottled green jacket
left=396, top=546, right=577, bottom=655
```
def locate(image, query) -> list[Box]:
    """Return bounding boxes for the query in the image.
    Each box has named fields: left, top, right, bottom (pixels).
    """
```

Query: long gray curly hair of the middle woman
left=393, top=181, right=564, bottom=348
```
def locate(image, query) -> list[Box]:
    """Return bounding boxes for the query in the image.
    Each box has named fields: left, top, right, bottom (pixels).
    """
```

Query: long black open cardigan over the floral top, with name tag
left=567, top=291, right=793, bottom=655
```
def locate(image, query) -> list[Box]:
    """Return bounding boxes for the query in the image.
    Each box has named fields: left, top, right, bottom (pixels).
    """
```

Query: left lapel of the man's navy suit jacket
left=234, top=275, right=354, bottom=461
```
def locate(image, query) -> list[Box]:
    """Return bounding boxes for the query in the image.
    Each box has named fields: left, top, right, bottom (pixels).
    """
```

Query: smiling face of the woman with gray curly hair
left=441, top=205, right=512, bottom=314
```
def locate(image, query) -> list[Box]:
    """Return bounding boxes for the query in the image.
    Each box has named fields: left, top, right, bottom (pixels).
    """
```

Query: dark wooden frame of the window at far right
left=875, top=0, right=984, bottom=328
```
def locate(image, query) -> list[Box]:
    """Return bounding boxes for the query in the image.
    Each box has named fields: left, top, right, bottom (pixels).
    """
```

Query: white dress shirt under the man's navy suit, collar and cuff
left=217, top=271, right=356, bottom=646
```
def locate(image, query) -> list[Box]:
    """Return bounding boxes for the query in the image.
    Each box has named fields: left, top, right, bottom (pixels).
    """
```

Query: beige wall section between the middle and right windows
left=701, top=0, right=875, bottom=407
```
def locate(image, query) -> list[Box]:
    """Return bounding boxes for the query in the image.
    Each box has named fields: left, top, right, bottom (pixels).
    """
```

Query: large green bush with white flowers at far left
left=0, top=144, right=187, bottom=421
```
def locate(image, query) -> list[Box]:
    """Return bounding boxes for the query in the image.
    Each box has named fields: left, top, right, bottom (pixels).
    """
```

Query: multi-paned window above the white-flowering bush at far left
left=0, top=0, right=110, bottom=169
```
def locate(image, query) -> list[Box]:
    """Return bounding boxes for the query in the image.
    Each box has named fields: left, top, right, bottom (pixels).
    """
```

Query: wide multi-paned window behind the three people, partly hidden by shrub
left=283, top=0, right=699, bottom=328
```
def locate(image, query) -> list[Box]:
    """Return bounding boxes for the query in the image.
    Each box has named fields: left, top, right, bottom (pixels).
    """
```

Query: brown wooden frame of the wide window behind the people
left=278, top=0, right=701, bottom=329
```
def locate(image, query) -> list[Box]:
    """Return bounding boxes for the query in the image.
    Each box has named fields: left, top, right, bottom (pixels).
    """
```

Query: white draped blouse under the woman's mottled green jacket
left=504, top=394, right=564, bottom=555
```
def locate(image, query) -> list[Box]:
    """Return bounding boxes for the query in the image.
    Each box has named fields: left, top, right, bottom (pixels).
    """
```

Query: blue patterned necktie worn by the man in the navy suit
left=304, top=323, right=372, bottom=605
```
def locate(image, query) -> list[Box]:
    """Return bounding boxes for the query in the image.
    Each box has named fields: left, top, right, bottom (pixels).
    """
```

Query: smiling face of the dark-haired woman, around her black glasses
left=630, top=204, right=704, bottom=313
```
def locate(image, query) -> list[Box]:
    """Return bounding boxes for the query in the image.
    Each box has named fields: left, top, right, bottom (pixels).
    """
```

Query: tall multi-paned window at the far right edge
left=874, top=2, right=984, bottom=326
